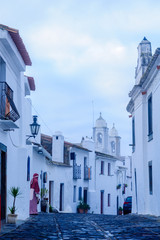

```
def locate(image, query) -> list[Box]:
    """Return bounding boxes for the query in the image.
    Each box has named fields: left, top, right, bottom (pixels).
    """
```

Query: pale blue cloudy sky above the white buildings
left=0, top=0, right=160, bottom=155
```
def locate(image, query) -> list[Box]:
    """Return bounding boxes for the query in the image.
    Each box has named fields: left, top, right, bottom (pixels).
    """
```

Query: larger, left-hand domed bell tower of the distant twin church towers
left=93, top=113, right=108, bottom=153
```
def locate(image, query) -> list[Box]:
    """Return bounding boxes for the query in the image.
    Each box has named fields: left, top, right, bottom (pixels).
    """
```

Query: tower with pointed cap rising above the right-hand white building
left=135, top=37, right=152, bottom=84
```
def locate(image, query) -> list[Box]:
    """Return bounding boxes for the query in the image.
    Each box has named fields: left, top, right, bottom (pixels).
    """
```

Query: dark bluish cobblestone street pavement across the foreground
left=0, top=213, right=160, bottom=240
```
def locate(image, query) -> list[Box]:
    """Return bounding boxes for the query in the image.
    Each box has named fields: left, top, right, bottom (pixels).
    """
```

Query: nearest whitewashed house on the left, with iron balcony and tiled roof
left=0, top=25, right=35, bottom=220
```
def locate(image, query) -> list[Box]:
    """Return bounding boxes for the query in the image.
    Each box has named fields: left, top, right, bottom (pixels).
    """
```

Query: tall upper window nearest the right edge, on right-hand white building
left=148, top=95, right=153, bottom=141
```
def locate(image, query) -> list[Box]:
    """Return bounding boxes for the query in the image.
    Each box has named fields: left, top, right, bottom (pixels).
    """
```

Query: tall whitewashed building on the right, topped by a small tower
left=127, top=38, right=160, bottom=216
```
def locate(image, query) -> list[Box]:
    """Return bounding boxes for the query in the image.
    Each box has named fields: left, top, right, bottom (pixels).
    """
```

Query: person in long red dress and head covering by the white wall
left=29, top=173, right=40, bottom=214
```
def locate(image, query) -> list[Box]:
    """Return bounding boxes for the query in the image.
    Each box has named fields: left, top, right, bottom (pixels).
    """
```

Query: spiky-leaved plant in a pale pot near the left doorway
left=7, top=187, right=21, bottom=224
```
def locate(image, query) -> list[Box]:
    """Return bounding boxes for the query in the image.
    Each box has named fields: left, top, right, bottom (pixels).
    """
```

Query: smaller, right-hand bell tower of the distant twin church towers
left=109, top=123, right=121, bottom=157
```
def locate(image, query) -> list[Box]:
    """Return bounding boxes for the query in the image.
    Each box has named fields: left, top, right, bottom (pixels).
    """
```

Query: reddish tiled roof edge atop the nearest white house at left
left=0, top=24, right=32, bottom=66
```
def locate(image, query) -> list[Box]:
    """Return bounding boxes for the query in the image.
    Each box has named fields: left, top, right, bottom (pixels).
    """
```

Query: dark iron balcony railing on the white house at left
left=0, top=82, right=20, bottom=122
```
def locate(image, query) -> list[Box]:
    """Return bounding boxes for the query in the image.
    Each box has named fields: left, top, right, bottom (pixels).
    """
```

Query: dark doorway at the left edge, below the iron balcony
left=0, top=143, right=7, bottom=220
